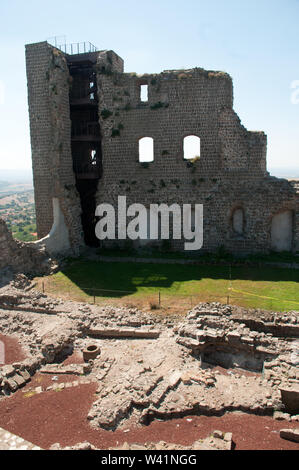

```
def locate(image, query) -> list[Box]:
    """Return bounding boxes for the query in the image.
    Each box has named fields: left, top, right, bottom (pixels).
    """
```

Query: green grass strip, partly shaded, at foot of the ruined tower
left=39, top=259, right=299, bottom=311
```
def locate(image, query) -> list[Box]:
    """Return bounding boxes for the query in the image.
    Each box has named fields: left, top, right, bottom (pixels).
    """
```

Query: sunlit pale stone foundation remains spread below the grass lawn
left=0, top=278, right=299, bottom=436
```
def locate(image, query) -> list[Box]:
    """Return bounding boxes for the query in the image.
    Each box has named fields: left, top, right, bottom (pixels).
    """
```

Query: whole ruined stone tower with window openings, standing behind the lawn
left=26, top=42, right=299, bottom=253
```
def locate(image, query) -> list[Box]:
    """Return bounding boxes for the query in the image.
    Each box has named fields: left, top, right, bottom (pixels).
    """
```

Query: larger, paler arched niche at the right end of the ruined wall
left=271, top=210, right=294, bottom=251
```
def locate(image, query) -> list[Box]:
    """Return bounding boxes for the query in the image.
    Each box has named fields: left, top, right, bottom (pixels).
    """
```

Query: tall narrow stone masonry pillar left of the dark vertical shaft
left=26, top=42, right=83, bottom=252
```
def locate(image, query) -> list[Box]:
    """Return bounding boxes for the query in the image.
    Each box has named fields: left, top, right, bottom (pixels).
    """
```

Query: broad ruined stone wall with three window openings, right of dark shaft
left=97, top=63, right=299, bottom=252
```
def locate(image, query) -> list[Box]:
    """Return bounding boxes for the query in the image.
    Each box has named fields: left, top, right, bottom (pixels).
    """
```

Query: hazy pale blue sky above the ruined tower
left=0, top=0, right=299, bottom=179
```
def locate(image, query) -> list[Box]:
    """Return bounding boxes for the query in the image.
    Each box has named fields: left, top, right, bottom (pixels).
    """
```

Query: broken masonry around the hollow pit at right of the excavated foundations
left=176, top=304, right=299, bottom=388
